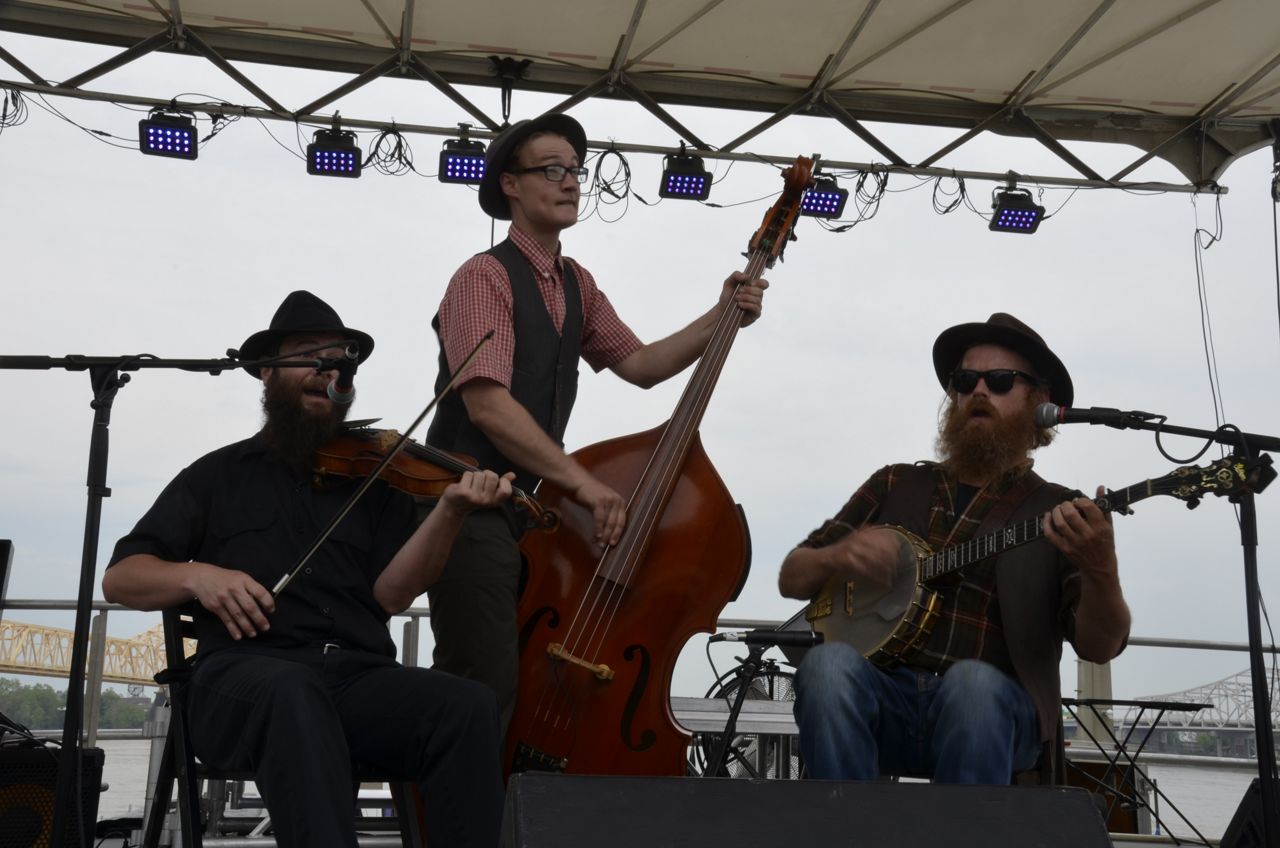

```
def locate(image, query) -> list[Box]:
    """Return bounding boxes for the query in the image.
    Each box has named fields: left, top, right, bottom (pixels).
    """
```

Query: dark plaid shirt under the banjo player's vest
left=800, top=465, right=1079, bottom=675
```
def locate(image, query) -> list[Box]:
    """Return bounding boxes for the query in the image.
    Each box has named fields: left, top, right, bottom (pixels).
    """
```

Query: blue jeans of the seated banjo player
left=795, top=643, right=1041, bottom=784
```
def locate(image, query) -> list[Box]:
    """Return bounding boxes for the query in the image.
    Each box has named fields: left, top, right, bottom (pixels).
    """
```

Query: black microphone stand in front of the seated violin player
left=0, top=351, right=340, bottom=845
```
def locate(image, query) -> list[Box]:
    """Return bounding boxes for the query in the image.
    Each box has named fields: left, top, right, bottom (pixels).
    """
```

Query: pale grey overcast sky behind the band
left=0, top=33, right=1280, bottom=697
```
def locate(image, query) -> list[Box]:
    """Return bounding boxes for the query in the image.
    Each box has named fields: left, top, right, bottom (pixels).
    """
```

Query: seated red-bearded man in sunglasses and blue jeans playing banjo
left=778, top=313, right=1129, bottom=784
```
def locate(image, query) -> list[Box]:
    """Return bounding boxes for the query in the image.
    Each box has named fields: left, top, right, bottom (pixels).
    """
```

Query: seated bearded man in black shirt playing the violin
left=102, top=291, right=511, bottom=848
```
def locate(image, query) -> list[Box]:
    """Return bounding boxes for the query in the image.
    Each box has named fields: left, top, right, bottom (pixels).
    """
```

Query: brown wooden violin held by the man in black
left=311, top=427, right=559, bottom=530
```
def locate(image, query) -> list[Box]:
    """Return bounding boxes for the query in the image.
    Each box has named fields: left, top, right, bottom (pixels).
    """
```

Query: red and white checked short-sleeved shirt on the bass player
left=439, top=225, right=644, bottom=388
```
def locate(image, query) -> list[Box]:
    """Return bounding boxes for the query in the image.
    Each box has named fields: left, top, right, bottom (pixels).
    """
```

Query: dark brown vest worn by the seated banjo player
left=874, top=465, right=1073, bottom=774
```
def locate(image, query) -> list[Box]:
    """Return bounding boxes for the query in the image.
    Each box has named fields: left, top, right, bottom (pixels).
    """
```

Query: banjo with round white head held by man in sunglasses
left=804, top=455, right=1275, bottom=667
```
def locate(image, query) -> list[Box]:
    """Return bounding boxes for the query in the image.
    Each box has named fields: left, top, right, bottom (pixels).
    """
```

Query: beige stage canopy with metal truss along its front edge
left=0, top=0, right=1280, bottom=187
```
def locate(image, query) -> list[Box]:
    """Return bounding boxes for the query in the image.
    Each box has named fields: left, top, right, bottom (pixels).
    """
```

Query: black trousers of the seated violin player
left=187, top=646, right=503, bottom=848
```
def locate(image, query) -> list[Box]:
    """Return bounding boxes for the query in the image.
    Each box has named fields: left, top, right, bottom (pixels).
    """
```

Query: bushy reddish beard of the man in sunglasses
left=937, top=395, right=1047, bottom=480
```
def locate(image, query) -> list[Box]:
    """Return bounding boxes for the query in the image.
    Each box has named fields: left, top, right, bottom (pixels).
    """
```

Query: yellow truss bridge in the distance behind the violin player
left=0, top=620, right=195, bottom=687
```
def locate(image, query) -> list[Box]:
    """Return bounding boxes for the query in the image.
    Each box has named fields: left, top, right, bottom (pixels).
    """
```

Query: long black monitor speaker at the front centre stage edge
left=502, top=772, right=1111, bottom=848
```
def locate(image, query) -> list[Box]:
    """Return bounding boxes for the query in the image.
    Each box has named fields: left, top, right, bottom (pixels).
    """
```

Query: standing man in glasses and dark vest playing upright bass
left=429, top=114, right=768, bottom=724
